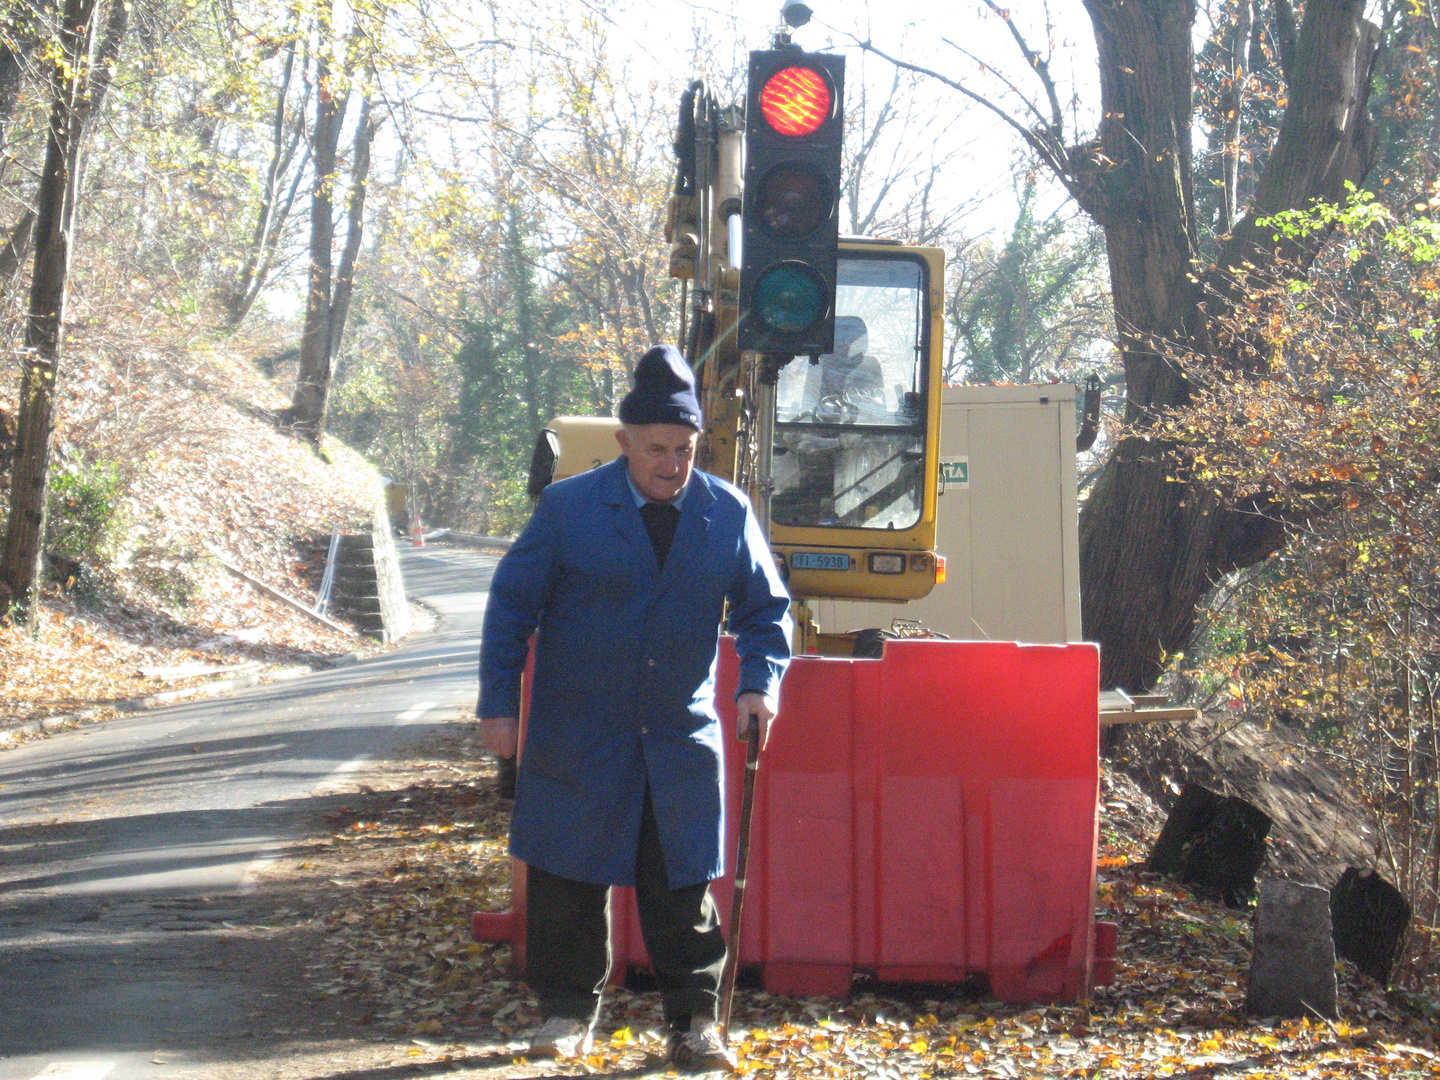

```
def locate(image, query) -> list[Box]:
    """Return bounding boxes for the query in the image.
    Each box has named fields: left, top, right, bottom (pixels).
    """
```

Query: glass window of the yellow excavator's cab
left=770, top=252, right=930, bottom=528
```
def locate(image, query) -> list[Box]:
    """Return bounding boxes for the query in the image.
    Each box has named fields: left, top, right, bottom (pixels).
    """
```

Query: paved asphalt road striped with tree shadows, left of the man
left=0, top=553, right=512, bottom=1080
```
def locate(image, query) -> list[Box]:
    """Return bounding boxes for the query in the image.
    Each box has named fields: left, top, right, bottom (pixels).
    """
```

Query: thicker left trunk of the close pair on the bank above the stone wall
left=285, top=44, right=344, bottom=446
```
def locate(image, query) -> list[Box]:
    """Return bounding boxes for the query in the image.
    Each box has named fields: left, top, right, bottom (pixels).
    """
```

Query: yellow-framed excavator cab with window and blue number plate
left=770, top=239, right=943, bottom=600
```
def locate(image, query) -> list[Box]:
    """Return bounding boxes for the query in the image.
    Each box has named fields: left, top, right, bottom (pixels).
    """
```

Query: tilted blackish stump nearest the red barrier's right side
left=1149, top=783, right=1270, bottom=907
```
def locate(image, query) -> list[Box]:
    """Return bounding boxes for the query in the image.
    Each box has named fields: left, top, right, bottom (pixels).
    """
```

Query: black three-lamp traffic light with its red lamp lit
left=737, top=49, right=845, bottom=356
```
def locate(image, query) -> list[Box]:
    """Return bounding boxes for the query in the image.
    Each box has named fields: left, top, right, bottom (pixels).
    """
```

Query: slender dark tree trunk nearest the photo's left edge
left=0, top=0, right=96, bottom=622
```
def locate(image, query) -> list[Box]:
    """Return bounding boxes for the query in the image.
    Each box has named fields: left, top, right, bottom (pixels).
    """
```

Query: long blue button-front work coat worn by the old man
left=478, top=458, right=791, bottom=888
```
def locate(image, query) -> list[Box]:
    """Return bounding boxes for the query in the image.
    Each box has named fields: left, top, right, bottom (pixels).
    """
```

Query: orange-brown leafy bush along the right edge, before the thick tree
left=1156, top=192, right=1440, bottom=979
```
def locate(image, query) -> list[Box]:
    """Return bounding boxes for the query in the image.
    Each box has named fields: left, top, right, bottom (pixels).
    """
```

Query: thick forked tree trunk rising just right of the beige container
left=1070, top=0, right=1378, bottom=690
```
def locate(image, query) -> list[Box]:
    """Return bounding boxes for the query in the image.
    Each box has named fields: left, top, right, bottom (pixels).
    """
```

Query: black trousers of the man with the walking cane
left=526, top=792, right=724, bottom=1030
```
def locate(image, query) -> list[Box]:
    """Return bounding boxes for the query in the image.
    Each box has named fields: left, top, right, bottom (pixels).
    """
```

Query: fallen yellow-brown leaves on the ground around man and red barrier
left=277, top=721, right=1440, bottom=1080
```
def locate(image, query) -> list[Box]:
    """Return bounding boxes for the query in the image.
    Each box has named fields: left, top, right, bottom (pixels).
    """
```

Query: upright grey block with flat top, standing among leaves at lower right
left=1246, top=880, right=1336, bottom=1020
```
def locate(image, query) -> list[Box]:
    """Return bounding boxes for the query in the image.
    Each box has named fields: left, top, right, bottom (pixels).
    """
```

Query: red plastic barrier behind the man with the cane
left=472, top=641, right=1113, bottom=1001
